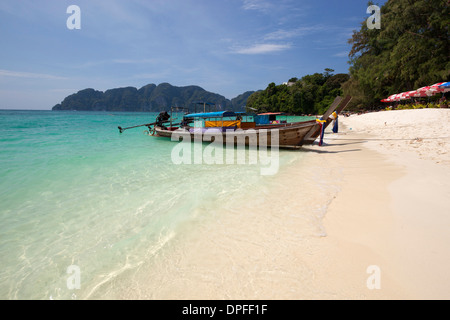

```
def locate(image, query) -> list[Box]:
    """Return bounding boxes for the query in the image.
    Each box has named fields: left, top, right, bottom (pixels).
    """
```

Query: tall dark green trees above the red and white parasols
left=343, top=0, right=450, bottom=109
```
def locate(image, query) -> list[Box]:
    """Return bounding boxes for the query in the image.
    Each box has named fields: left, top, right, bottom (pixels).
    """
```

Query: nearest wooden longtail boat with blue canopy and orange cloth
left=148, top=96, right=351, bottom=148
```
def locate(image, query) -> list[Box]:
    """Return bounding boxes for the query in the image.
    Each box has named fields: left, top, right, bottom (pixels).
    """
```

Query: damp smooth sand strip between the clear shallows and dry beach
left=298, top=129, right=413, bottom=300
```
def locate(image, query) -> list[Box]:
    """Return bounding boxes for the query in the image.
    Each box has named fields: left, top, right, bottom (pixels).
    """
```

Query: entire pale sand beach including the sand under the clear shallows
left=102, top=109, right=450, bottom=300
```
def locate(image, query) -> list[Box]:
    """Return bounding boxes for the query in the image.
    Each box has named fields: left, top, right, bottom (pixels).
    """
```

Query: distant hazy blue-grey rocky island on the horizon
left=52, top=83, right=254, bottom=112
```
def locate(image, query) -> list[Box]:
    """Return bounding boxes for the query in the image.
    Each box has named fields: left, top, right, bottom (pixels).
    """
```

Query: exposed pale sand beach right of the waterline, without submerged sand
left=306, top=109, right=450, bottom=299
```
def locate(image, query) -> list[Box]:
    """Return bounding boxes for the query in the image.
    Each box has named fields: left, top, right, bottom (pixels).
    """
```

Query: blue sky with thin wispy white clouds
left=0, top=0, right=385, bottom=110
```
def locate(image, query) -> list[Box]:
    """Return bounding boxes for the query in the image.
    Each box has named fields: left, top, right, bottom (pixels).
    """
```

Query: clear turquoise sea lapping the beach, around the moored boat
left=0, top=110, right=324, bottom=299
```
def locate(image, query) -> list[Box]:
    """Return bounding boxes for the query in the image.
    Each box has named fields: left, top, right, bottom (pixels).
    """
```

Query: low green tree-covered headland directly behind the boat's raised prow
left=247, top=69, right=349, bottom=114
